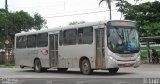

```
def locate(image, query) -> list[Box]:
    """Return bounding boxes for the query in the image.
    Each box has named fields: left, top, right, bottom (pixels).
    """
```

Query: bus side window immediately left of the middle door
left=37, top=33, right=48, bottom=47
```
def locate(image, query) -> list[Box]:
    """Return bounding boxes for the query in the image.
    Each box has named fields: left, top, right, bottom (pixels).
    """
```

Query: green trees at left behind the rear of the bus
left=0, top=9, right=46, bottom=47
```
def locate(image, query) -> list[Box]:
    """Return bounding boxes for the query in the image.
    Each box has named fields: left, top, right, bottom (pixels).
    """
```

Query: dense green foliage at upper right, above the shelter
left=116, top=1, right=160, bottom=36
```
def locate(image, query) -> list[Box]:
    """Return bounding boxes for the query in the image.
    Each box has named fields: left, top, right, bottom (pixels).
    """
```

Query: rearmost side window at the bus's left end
left=16, top=36, right=26, bottom=48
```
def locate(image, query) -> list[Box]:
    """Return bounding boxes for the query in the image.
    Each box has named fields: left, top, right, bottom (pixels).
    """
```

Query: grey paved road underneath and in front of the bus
left=0, top=64, right=160, bottom=84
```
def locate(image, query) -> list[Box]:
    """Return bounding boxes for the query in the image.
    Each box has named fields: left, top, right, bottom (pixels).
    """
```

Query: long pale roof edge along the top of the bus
left=15, top=20, right=134, bottom=36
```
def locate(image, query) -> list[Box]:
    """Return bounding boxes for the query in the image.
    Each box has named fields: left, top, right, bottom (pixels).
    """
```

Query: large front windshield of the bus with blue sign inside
left=107, top=26, right=139, bottom=54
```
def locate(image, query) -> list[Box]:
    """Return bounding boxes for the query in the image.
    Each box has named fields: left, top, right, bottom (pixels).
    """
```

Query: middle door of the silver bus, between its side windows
left=49, top=34, right=58, bottom=67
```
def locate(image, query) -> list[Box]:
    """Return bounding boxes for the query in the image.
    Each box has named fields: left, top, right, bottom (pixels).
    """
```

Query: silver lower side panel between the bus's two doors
left=59, top=44, right=95, bottom=68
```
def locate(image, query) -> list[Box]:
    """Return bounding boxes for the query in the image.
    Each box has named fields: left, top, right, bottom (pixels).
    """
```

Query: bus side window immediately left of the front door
left=78, top=27, right=93, bottom=44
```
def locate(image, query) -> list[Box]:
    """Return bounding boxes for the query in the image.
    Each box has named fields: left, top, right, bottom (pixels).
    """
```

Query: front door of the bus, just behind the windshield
left=95, top=28, right=105, bottom=69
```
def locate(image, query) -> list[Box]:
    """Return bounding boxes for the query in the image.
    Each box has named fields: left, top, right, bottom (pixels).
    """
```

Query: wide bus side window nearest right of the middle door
left=63, top=29, right=77, bottom=45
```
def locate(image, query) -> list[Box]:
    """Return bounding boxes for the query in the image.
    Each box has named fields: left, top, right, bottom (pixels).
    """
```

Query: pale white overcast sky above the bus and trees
left=0, top=0, right=156, bottom=28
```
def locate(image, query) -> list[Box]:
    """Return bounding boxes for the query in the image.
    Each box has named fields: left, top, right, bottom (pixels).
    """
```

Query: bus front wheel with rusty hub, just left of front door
left=80, top=59, right=93, bottom=75
